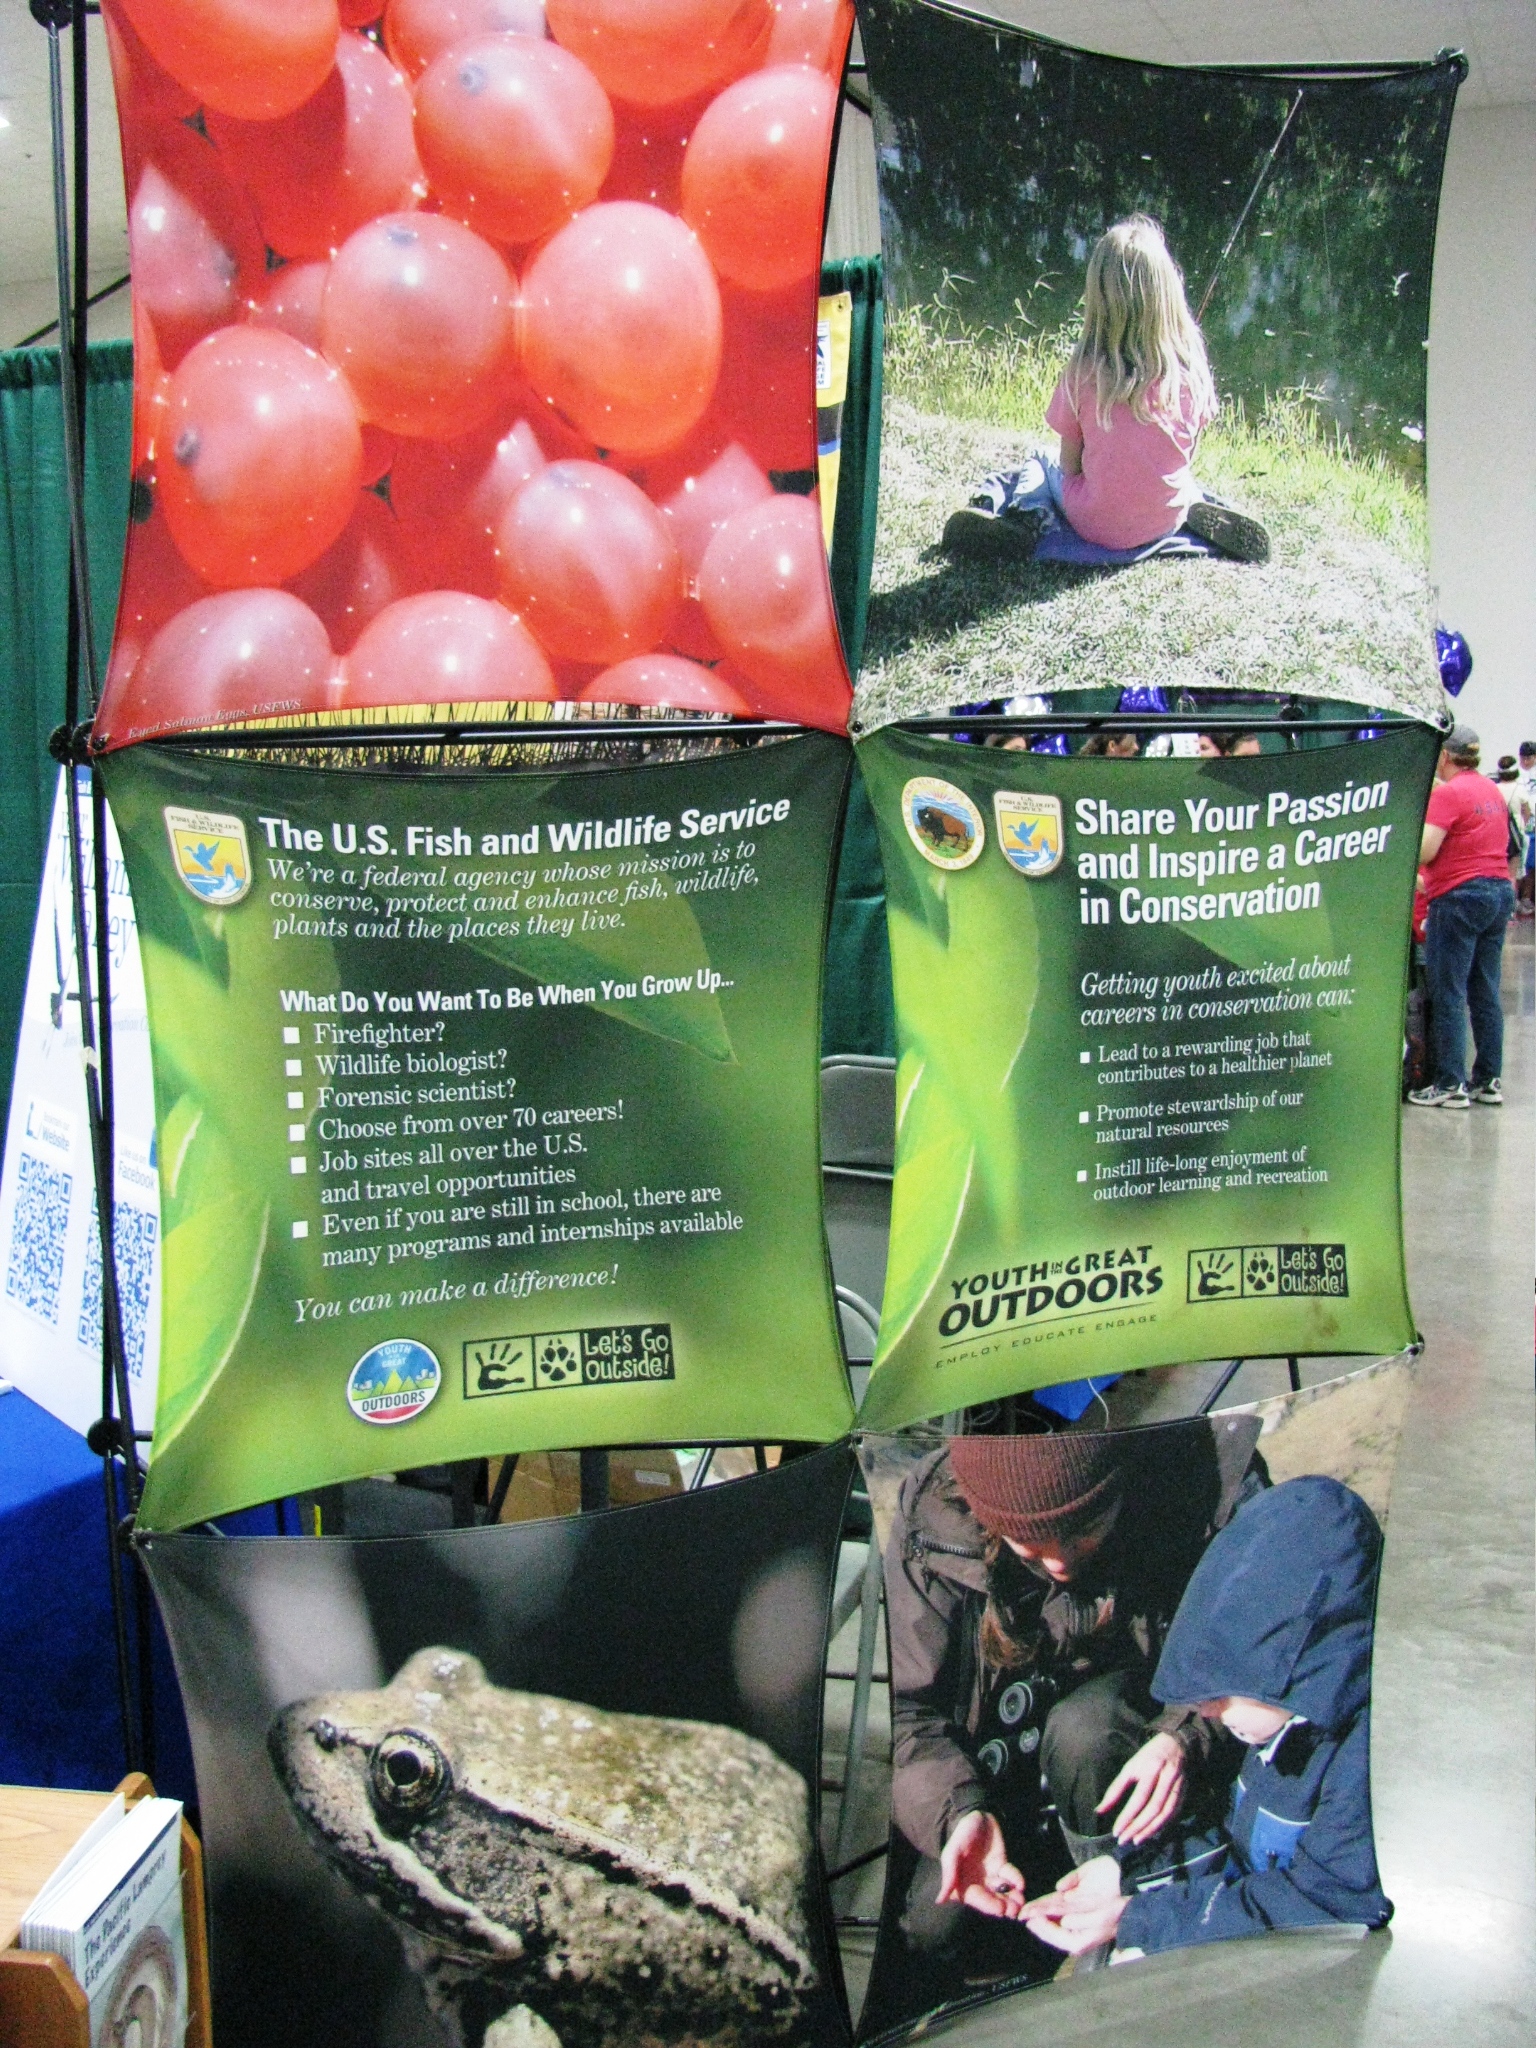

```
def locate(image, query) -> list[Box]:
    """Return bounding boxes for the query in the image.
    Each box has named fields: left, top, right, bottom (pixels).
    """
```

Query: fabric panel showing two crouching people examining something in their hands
left=858, top=1360, right=1411, bottom=2042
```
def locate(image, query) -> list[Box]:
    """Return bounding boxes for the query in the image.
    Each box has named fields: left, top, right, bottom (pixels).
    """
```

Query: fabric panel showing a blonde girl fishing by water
left=858, top=0, right=1466, bottom=731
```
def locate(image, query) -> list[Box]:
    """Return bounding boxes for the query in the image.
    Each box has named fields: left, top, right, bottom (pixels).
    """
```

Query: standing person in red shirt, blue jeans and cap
left=1409, top=725, right=1516, bottom=1110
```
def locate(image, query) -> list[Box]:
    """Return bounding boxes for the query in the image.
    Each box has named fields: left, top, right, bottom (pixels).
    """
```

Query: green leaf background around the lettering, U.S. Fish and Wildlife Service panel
left=104, top=735, right=852, bottom=1528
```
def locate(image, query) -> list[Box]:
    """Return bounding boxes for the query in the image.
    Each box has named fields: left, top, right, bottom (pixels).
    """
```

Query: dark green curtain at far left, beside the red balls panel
left=0, top=342, right=133, bottom=1130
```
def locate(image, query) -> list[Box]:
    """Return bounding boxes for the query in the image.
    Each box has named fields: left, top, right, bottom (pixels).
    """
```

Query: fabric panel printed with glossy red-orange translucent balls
left=96, top=0, right=852, bottom=745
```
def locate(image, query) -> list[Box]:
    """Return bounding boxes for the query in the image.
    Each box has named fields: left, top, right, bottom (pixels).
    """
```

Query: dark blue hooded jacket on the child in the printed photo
left=1118, top=1479, right=1393, bottom=1952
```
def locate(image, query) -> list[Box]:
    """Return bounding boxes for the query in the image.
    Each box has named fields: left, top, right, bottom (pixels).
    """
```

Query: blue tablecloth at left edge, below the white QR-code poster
left=0, top=1391, right=197, bottom=1802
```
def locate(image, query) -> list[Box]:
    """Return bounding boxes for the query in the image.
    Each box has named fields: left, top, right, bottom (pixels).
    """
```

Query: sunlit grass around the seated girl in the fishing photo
left=858, top=295, right=1440, bottom=727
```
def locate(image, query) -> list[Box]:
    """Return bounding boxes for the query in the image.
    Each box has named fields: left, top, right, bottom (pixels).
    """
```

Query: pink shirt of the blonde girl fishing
left=1044, top=377, right=1210, bottom=547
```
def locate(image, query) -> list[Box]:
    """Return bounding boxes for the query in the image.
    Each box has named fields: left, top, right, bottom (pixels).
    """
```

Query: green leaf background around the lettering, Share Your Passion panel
left=858, top=727, right=1436, bottom=1427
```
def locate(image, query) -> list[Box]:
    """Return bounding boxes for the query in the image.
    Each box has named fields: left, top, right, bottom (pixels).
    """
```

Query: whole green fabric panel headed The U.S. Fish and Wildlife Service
left=102, top=733, right=852, bottom=1528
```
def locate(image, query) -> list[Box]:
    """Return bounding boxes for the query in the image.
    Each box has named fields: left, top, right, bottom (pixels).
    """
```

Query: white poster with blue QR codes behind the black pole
left=0, top=772, right=160, bottom=1436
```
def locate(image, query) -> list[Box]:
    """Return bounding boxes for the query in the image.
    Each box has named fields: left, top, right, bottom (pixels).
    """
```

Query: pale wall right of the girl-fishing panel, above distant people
left=1425, top=104, right=1536, bottom=768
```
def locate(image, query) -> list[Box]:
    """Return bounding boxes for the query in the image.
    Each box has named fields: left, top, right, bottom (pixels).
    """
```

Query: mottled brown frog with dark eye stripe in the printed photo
left=268, top=1647, right=817, bottom=2048
